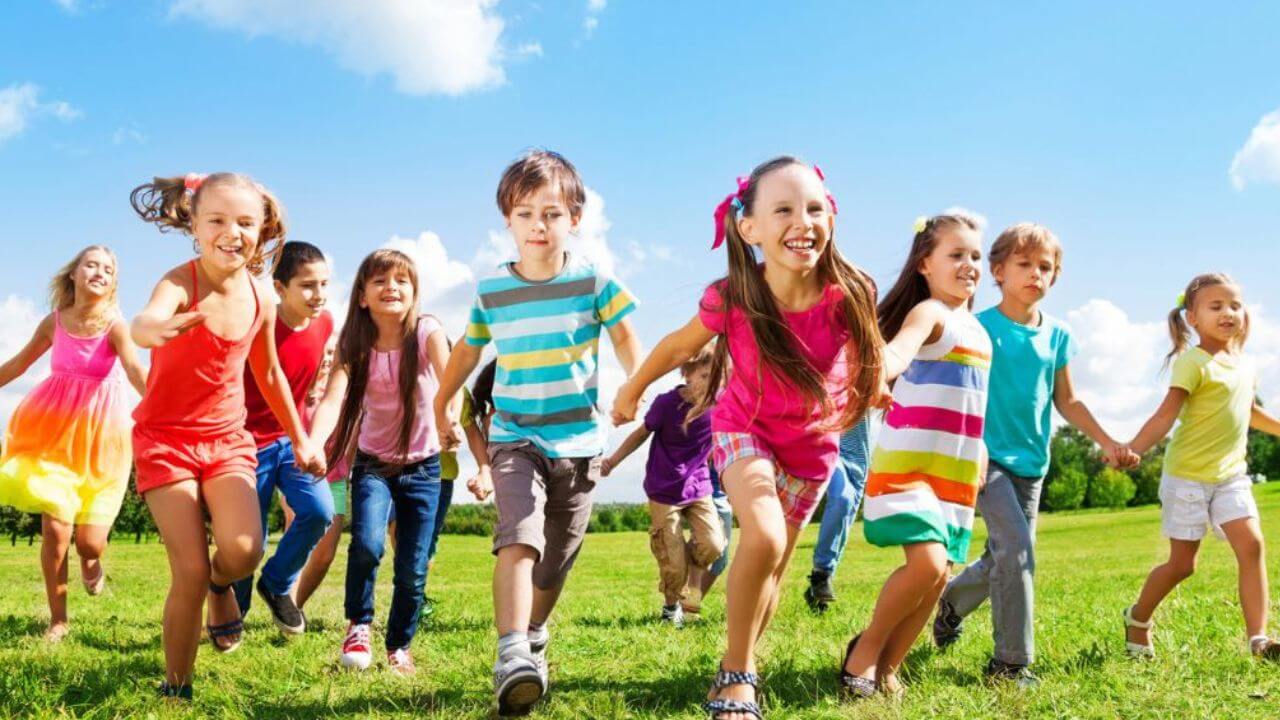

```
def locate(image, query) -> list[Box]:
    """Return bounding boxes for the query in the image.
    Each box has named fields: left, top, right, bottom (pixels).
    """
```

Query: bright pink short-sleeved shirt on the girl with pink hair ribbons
left=698, top=281, right=850, bottom=480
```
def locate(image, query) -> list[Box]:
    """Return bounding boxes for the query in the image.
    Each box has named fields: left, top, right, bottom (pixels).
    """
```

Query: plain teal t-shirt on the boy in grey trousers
left=978, top=302, right=1076, bottom=478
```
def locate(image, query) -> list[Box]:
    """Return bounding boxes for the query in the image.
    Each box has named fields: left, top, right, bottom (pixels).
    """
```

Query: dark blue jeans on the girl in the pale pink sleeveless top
left=346, top=452, right=440, bottom=652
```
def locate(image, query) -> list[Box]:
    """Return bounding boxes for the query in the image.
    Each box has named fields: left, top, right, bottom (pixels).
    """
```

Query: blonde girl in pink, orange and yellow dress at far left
left=0, top=245, right=146, bottom=642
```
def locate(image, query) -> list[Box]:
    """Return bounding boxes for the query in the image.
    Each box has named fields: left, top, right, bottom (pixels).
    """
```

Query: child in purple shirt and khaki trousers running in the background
left=600, top=345, right=726, bottom=628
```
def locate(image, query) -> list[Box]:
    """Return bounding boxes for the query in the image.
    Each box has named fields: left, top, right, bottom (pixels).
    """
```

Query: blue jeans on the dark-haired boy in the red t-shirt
left=236, top=438, right=333, bottom=614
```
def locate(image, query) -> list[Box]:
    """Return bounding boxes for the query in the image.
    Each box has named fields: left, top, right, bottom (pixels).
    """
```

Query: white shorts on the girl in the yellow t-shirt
left=1160, top=473, right=1258, bottom=541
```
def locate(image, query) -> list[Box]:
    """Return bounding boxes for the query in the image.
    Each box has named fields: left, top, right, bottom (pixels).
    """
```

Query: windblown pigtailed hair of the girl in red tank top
left=129, top=173, right=287, bottom=275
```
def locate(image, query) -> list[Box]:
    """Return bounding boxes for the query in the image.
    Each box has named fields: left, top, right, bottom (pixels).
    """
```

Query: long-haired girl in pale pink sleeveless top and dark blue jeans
left=311, top=250, right=448, bottom=675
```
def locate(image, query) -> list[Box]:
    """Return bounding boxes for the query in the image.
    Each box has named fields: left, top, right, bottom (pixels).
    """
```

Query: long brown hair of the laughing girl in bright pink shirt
left=689, top=155, right=884, bottom=429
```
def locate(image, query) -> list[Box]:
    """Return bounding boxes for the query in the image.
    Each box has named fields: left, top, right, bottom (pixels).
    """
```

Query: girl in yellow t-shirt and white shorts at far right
left=1124, top=273, right=1280, bottom=660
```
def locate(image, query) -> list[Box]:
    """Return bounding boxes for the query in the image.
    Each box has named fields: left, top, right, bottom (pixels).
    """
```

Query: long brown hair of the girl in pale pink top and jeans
left=325, top=250, right=420, bottom=468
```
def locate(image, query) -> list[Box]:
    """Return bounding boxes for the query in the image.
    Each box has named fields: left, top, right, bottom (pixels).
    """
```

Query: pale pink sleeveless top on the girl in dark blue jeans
left=358, top=315, right=443, bottom=464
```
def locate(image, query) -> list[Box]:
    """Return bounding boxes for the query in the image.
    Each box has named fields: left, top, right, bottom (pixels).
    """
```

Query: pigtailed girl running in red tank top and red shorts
left=131, top=173, right=324, bottom=700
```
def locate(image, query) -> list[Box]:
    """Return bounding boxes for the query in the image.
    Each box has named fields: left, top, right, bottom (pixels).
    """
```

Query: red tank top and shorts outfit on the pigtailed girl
left=133, top=260, right=262, bottom=495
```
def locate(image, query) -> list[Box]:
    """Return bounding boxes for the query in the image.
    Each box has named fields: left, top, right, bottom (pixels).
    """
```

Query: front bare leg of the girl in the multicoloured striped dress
left=845, top=542, right=947, bottom=679
